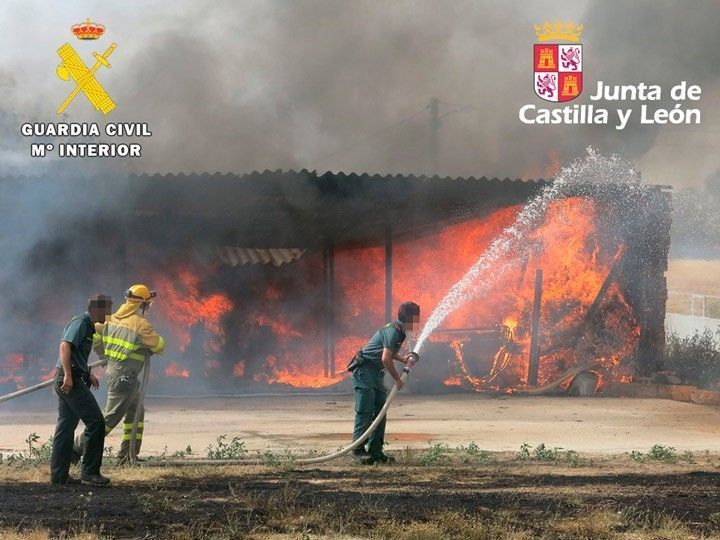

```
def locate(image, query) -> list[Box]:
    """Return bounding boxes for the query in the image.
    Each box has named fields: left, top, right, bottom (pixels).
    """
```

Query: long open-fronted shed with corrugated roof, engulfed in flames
left=0, top=170, right=670, bottom=392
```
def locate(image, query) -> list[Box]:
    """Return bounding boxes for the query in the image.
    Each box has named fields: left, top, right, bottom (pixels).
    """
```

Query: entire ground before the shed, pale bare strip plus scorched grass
left=0, top=394, right=720, bottom=540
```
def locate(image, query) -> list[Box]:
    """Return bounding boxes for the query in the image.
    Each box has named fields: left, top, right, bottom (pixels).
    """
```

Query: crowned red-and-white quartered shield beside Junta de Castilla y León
left=533, top=21, right=583, bottom=102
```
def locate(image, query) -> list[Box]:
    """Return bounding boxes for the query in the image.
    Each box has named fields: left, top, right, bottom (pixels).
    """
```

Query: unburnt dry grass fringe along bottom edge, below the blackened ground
left=0, top=510, right=708, bottom=540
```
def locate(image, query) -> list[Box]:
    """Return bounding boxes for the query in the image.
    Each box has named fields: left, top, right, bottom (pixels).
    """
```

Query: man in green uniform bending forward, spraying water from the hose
left=348, top=302, right=420, bottom=465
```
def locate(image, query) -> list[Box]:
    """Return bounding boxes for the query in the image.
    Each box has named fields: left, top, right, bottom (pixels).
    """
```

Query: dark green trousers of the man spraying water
left=352, top=366, right=387, bottom=457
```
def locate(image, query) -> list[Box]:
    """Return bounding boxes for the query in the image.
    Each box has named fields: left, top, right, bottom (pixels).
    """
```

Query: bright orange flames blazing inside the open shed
left=115, top=198, right=639, bottom=392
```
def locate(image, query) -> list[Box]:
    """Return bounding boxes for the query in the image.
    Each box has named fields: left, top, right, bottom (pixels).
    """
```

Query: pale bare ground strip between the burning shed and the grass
left=0, top=394, right=720, bottom=457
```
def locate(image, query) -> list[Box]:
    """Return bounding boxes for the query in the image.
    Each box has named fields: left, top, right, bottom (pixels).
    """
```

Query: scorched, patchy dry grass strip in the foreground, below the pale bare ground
left=0, top=452, right=720, bottom=540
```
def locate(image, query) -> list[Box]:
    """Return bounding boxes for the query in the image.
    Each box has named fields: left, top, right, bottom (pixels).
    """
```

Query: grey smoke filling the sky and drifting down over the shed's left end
left=0, top=0, right=720, bottom=388
